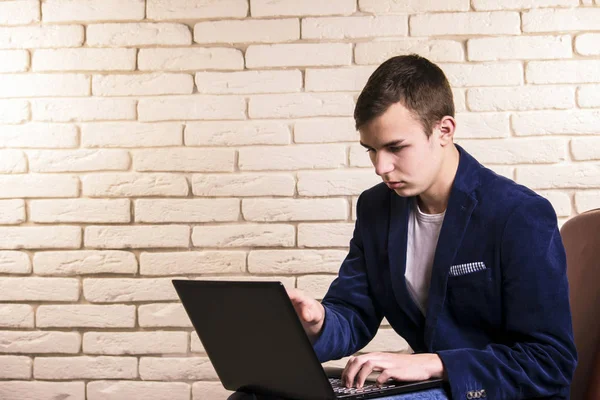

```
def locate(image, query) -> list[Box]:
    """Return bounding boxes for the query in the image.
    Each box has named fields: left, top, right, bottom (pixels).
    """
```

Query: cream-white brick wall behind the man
left=0, top=0, right=600, bottom=400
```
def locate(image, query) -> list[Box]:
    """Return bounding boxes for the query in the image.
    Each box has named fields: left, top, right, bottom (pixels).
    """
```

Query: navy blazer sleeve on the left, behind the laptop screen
left=313, top=196, right=383, bottom=362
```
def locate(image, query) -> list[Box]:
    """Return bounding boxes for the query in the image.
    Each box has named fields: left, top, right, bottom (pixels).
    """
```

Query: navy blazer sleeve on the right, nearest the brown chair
left=437, top=197, right=577, bottom=400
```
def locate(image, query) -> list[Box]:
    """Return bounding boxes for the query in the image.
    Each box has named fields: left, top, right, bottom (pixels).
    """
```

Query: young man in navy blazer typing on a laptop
left=289, top=55, right=577, bottom=400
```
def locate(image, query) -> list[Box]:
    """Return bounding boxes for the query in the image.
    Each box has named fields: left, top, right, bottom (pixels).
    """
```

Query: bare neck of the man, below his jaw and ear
left=417, top=145, right=460, bottom=214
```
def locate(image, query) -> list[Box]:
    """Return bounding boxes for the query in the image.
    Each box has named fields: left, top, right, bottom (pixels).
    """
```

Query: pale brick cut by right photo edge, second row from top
left=522, top=7, right=600, bottom=32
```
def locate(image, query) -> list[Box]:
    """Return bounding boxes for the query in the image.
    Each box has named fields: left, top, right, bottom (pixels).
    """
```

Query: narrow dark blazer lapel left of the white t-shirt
left=388, top=191, right=425, bottom=327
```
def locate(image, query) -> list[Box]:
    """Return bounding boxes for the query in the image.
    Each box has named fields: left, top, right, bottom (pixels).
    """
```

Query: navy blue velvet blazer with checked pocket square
left=314, top=146, right=577, bottom=400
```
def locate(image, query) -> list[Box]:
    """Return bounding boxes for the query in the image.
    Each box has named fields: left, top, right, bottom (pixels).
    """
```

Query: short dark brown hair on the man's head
left=354, top=54, right=454, bottom=136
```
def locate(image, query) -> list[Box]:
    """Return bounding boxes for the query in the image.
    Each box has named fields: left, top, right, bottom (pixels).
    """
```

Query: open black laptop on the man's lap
left=173, top=280, right=442, bottom=400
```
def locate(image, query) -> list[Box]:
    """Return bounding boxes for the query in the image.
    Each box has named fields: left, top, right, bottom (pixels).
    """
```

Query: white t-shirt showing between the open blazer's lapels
left=404, top=198, right=446, bottom=315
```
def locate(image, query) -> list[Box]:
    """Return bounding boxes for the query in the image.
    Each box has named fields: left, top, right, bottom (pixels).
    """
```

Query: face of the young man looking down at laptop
left=359, top=103, right=443, bottom=197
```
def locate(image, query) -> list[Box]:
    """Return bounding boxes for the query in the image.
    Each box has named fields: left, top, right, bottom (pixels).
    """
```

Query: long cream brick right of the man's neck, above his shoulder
left=460, top=138, right=567, bottom=164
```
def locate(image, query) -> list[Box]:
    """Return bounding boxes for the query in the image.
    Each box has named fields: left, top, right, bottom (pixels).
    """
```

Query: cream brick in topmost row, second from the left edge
left=42, top=0, right=146, bottom=22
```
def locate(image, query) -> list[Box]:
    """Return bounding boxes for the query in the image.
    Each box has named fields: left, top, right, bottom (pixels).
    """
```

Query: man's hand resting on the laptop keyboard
left=342, top=353, right=445, bottom=388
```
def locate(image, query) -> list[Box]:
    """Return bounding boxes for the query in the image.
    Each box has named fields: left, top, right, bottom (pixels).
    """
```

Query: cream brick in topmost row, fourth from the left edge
left=250, top=0, right=356, bottom=17
